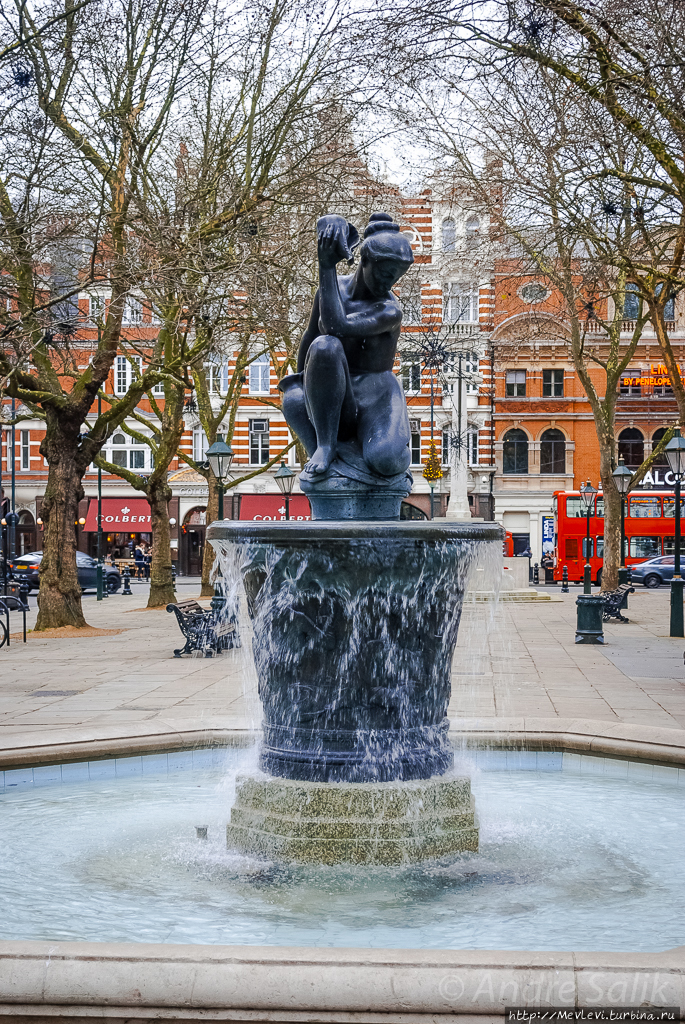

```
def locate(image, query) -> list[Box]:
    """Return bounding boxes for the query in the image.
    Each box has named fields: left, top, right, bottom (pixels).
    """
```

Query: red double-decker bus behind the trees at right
left=553, top=490, right=685, bottom=584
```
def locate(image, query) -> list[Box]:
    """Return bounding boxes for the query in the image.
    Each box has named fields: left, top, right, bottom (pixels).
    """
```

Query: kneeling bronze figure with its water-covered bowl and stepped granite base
left=208, top=213, right=502, bottom=864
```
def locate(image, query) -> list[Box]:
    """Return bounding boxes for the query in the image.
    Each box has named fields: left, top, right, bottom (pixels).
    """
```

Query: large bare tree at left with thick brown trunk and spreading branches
left=0, top=0, right=210, bottom=630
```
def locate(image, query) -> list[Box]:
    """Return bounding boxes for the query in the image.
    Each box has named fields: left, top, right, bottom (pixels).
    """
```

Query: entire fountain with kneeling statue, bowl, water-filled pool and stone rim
left=0, top=215, right=685, bottom=1007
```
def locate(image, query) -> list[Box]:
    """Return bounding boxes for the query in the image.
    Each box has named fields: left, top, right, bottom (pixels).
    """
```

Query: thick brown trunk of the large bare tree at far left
left=35, top=430, right=87, bottom=631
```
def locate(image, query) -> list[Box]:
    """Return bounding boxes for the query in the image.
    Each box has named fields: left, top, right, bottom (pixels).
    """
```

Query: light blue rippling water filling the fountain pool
left=0, top=750, right=685, bottom=951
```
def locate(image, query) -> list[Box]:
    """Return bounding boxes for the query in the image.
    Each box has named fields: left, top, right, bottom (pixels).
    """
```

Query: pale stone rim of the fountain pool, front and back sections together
left=0, top=718, right=685, bottom=1024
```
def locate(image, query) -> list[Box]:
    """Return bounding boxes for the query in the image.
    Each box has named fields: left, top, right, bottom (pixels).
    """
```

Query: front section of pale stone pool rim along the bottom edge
left=0, top=940, right=685, bottom=1024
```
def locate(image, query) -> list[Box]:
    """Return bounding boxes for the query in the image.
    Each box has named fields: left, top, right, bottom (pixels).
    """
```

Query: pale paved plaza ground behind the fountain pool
left=0, top=582, right=685, bottom=748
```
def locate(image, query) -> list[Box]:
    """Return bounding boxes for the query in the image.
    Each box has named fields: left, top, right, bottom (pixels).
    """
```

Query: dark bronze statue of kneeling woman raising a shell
left=279, top=213, right=414, bottom=492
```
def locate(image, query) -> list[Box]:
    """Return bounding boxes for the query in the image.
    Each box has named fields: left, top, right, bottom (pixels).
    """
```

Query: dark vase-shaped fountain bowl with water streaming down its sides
left=207, top=520, right=504, bottom=782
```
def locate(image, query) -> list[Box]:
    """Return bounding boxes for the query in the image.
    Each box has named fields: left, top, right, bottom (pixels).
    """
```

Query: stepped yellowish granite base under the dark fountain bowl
left=226, top=773, right=478, bottom=865
